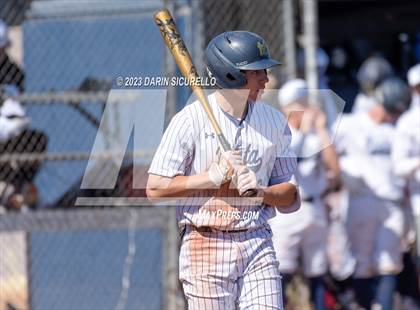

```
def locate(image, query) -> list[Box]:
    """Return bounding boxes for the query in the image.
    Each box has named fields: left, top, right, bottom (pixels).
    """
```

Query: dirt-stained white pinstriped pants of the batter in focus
left=179, top=226, right=283, bottom=310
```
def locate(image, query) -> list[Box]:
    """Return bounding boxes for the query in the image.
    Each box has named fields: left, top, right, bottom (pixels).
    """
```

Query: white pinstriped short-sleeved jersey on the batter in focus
left=149, top=93, right=296, bottom=230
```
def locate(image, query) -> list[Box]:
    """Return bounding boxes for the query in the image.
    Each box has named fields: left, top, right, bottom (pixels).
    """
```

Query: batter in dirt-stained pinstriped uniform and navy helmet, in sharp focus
left=147, top=31, right=300, bottom=309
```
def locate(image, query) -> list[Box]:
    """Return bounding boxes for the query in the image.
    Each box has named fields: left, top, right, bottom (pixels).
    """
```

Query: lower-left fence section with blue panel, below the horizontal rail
left=0, top=207, right=182, bottom=309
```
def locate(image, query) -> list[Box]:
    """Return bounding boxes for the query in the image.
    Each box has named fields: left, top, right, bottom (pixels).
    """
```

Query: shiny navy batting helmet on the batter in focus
left=205, top=31, right=280, bottom=88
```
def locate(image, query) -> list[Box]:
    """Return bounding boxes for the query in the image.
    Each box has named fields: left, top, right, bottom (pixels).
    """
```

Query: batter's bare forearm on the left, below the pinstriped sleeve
left=146, top=171, right=214, bottom=202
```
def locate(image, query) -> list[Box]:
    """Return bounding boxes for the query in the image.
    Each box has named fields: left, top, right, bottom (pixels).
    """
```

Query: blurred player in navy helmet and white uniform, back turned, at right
left=335, top=78, right=410, bottom=309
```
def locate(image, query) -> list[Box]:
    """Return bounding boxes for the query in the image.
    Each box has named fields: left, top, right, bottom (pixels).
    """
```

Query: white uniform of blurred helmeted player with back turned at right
left=335, top=113, right=404, bottom=278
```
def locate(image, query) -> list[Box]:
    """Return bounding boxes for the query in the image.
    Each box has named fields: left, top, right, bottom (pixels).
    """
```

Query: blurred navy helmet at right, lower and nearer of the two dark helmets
left=375, top=77, right=411, bottom=113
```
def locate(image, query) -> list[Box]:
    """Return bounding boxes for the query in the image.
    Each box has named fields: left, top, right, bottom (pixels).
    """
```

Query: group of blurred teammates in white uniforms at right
left=271, top=61, right=420, bottom=309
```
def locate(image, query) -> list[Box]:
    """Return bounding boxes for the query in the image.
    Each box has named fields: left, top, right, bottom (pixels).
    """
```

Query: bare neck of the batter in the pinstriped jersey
left=216, top=89, right=248, bottom=119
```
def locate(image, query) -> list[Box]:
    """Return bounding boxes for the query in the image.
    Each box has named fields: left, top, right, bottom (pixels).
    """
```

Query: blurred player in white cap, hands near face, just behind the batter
left=270, top=80, right=339, bottom=309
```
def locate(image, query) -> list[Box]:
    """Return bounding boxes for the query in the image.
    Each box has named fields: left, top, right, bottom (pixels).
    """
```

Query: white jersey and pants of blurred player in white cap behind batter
left=269, top=128, right=328, bottom=277
